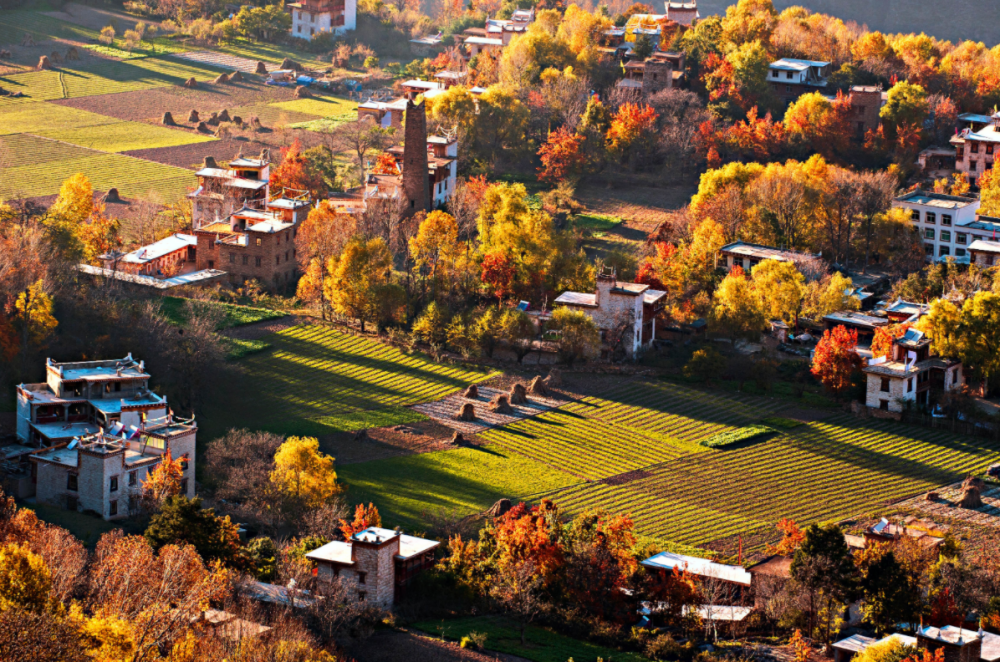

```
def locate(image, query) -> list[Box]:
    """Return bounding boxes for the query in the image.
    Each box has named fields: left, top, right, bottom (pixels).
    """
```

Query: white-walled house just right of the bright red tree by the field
left=863, top=328, right=964, bottom=412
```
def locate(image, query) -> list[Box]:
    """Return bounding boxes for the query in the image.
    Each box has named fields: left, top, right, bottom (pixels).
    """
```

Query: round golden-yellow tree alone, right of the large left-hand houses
left=271, top=437, right=340, bottom=508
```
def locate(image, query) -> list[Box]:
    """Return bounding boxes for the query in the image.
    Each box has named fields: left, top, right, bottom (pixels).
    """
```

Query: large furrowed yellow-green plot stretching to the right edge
left=547, top=415, right=1000, bottom=547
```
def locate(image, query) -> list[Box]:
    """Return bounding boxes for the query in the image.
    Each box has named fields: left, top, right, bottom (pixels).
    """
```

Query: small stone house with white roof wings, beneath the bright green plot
left=306, top=526, right=441, bottom=609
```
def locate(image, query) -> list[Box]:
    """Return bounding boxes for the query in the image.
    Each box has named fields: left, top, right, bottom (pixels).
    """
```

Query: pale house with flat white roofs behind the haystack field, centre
left=554, top=271, right=667, bottom=357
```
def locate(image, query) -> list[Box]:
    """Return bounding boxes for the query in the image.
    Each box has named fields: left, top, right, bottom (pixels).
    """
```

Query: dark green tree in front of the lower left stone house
left=143, top=495, right=240, bottom=565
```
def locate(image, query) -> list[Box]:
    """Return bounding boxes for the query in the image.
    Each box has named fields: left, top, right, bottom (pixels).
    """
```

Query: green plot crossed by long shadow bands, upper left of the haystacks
left=197, top=326, right=488, bottom=444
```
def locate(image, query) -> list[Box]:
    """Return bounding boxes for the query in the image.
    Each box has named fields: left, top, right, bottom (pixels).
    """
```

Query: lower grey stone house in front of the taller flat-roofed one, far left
left=28, top=414, right=198, bottom=520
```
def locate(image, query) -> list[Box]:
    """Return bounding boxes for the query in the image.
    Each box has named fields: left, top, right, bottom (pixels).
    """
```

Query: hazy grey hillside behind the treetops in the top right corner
left=696, top=0, right=1000, bottom=47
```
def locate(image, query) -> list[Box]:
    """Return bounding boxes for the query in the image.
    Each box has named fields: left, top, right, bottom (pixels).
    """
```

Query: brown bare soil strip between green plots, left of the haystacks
left=320, top=420, right=481, bottom=464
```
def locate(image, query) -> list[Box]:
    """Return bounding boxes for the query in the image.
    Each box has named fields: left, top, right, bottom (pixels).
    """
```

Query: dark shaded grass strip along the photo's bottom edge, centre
left=413, top=616, right=647, bottom=662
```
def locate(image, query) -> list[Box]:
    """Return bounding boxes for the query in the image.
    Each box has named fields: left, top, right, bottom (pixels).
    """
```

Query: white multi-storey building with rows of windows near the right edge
left=892, top=190, right=984, bottom=262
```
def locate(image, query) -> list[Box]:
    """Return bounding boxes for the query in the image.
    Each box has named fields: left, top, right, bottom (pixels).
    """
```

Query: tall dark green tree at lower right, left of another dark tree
left=791, top=524, right=857, bottom=643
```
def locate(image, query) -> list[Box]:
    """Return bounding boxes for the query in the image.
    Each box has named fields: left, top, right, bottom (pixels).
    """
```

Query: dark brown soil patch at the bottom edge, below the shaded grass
left=346, top=631, right=527, bottom=662
